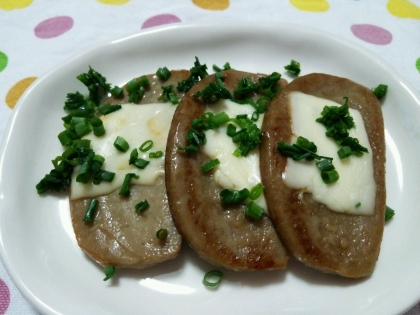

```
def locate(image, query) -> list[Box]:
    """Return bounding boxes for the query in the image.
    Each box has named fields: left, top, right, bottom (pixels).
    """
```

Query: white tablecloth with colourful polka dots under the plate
left=0, top=0, right=420, bottom=315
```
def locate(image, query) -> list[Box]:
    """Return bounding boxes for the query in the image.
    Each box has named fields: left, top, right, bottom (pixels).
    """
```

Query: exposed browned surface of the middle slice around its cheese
left=165, top=70, right=288, bottom=270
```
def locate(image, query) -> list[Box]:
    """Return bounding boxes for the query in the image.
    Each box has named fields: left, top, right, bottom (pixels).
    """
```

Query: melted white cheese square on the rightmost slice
left=283, top=92, right=376, bottom=215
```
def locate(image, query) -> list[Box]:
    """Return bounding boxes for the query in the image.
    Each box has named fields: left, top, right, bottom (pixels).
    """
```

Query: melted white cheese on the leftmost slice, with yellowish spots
left=70, top=103, right=176, bottom=199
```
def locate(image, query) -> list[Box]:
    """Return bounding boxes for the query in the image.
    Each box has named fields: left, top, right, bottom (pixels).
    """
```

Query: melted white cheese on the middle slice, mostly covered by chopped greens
left=202, top=100, right=268, bottom=214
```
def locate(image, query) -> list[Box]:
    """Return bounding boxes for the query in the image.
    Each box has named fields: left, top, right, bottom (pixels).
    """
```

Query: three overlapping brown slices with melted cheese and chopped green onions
left=37, top=58, right=392, bottom=285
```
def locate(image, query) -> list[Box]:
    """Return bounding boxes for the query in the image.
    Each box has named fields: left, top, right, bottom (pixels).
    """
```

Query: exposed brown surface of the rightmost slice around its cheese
left=260, top=74, right=385, bottom=278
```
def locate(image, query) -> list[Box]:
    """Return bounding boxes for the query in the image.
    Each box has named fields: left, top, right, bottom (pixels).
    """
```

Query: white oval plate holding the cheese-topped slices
left=0, top=22, right=420, bottom=315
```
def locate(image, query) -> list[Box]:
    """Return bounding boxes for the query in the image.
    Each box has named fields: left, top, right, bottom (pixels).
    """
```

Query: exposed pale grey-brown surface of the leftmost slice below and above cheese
left=70, top=70, right=189, bottom=268
